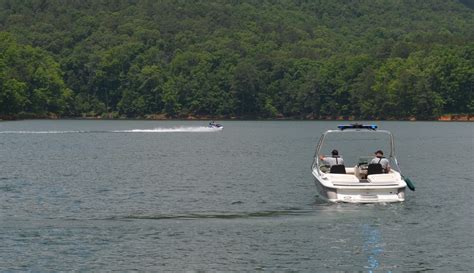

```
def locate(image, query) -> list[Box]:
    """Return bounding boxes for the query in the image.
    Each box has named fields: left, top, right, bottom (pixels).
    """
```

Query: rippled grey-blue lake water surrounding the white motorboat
left=0, top=120, right=474, bottom=272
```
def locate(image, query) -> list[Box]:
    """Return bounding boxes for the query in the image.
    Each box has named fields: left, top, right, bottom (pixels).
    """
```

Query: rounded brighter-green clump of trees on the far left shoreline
left=0, top=33, right=72, bottom=115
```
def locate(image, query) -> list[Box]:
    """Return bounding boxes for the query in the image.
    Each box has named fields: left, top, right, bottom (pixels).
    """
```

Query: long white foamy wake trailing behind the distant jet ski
left=0, top=126, right=222, bottom=134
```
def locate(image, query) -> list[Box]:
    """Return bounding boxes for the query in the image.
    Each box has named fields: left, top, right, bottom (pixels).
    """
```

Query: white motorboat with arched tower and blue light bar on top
left=312, top=124, right=414, bottom=203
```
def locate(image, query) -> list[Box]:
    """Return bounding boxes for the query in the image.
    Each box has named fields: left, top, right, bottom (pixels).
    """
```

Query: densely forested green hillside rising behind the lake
left=0, top=0, right=474, bottom=119
